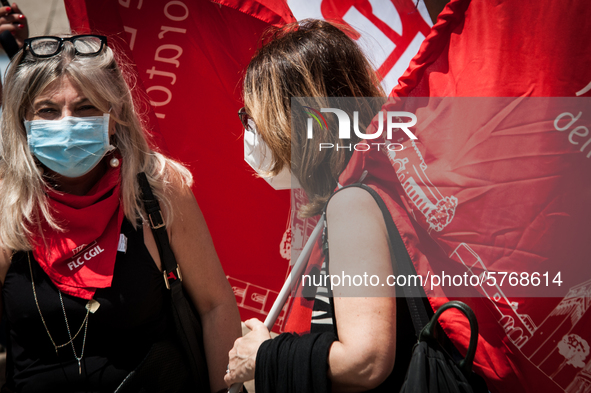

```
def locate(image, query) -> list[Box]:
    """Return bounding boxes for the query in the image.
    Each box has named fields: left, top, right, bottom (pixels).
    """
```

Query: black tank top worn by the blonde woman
left=2, top=220, right=169, bottom=392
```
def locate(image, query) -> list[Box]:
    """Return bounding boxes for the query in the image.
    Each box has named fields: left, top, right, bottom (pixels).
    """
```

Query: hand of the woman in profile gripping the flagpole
left=224, top=318, right=271, bottom=386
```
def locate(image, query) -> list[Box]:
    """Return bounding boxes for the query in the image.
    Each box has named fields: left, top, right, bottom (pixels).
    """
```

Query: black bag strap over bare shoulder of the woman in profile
left=323, top=183, right=430, bottom=339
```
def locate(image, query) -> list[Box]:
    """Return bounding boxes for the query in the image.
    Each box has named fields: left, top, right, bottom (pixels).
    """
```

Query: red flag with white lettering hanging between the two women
left=65, top=0, right=293, bottom=328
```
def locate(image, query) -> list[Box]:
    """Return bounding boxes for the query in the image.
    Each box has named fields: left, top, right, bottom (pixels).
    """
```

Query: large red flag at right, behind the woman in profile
left=374, top=0, right=591, bottom=392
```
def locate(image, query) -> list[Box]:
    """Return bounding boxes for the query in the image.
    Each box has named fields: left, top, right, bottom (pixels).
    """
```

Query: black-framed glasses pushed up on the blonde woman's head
left=23, top=34, right=107, bottom=58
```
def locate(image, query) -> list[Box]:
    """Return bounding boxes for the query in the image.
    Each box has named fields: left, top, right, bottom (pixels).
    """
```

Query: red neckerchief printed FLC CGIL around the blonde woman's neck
left=31, top=167, right=124, bottom=299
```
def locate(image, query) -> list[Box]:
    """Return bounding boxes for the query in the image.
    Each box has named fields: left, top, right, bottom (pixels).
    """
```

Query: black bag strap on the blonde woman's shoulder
left=137, top=172, right=183, bottom=289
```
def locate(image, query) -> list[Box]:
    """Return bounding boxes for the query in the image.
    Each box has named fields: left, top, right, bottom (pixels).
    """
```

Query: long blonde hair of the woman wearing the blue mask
left=0, top=37, right=193, bottom=251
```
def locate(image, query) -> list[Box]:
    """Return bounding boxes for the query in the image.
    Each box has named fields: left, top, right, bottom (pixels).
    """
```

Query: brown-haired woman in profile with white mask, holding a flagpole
left=226, top=20, right=414, bottom=393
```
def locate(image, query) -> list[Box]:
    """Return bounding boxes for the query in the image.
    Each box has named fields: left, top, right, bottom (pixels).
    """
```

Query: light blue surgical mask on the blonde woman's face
left=25, top=113, right=115, bottom=177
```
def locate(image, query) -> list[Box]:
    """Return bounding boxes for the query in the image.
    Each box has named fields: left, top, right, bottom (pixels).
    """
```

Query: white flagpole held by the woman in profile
left=228, top=215, right=324, bottom=393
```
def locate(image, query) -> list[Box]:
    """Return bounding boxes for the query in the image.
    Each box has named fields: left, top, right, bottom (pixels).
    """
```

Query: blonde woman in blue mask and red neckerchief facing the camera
left=0, top=35, right=240, bottom=392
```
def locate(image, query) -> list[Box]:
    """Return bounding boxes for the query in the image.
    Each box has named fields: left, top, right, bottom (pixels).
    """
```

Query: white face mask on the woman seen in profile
left=244, top=120, right=301, bottom=190
